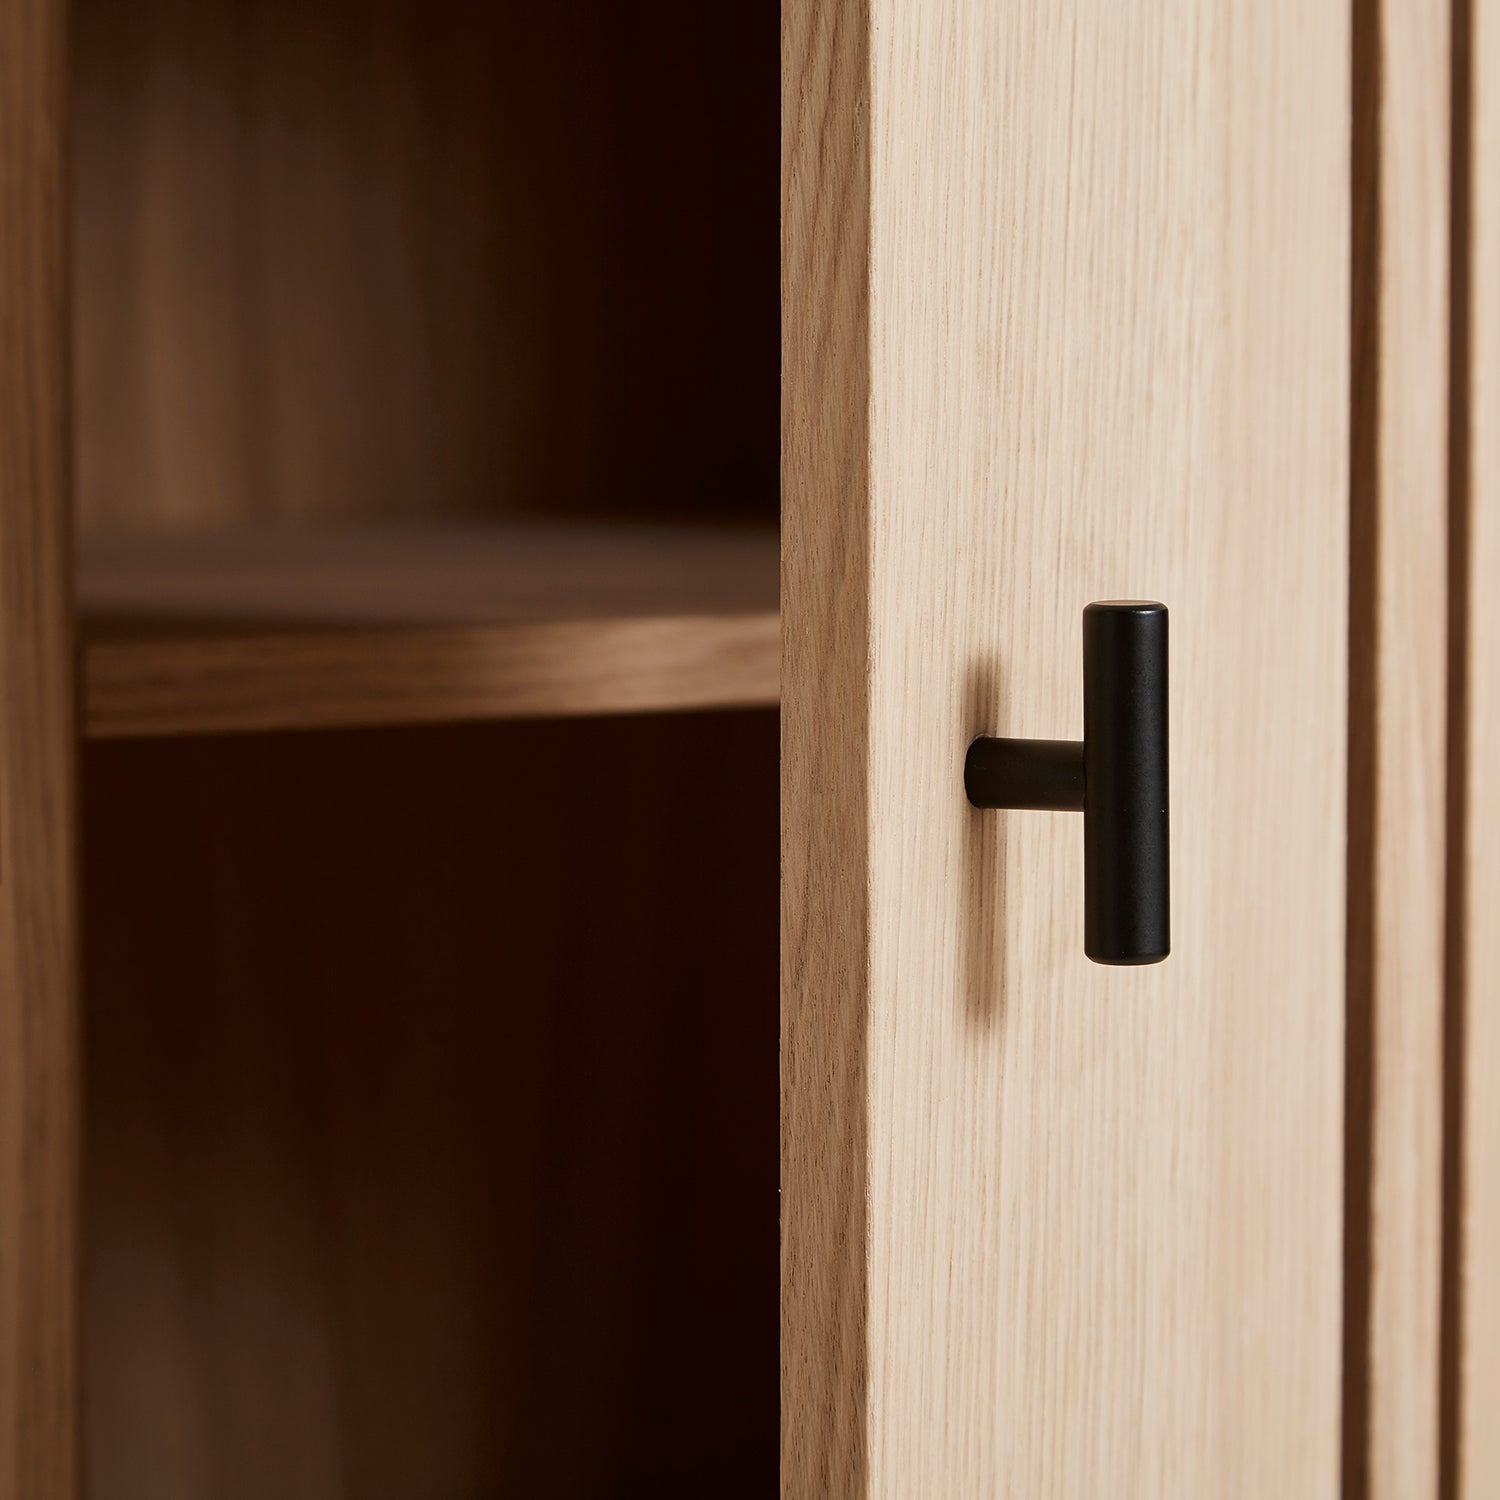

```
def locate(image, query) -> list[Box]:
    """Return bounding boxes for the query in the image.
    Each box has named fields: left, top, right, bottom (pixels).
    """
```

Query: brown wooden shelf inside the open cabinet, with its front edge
left=78, top=524, right=780, bottom=738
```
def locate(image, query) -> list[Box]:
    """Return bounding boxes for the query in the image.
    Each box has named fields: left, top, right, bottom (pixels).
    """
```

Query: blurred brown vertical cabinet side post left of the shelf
left=0, top=0, right=78, bottom=1500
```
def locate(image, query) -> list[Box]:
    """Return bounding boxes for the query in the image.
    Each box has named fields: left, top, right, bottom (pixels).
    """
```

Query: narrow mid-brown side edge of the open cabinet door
left=782, top=0, right=870, bottom=1497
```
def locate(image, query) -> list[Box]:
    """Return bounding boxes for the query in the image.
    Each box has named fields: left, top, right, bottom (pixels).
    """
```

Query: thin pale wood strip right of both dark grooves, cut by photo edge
left=1454, top=3, right=1500, bottom=1500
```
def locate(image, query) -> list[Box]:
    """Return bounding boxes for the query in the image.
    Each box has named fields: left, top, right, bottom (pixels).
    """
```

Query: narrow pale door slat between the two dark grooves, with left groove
left=1344, top=0, right=1451, bottom=1500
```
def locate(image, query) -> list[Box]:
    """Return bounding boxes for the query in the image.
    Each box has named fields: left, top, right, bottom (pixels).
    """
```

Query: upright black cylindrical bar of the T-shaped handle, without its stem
left=1083, top=600, right=1172, bottom=963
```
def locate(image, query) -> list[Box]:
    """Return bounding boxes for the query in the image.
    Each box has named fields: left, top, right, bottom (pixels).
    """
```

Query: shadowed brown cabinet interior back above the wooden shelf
left=74, top=0, right=779, bottom=528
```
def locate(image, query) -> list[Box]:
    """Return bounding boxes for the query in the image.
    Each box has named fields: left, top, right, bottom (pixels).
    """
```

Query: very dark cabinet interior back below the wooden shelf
left=84, top=713, right=777, bottom=1500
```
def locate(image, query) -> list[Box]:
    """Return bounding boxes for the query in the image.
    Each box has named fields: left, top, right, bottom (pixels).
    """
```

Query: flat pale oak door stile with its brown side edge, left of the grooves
left=782, top=0, right=1350, bottom=1500
